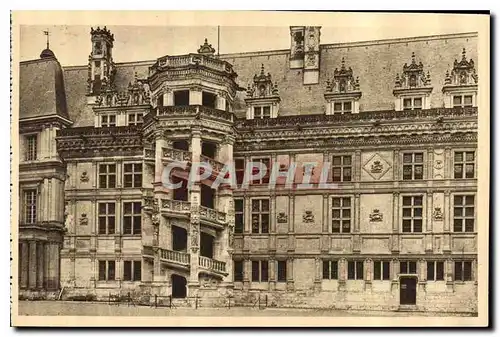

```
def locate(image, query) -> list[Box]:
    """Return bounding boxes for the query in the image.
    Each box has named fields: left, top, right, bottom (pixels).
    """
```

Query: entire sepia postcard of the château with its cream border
left=11, top=11, right=490, bottom=326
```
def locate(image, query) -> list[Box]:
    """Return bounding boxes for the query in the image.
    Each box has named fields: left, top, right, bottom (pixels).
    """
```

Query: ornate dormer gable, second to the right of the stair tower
left=325, top=58, right=361, bottom=115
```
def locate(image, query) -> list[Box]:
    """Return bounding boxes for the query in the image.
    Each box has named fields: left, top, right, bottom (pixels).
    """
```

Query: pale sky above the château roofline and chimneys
left=19, top=24, right=473, bottom=66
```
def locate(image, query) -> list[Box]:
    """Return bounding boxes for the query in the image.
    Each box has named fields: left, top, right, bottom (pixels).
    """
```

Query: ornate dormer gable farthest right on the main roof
left=443, top=48, right=478, bottom=108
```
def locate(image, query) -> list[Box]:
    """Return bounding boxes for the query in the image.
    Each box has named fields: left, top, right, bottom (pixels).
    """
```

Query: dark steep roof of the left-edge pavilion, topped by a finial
left=19, top=57, right=69, bottom=120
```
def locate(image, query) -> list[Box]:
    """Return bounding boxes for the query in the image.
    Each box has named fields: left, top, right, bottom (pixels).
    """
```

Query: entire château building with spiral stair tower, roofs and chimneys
left=19, top=26, right=479, bottom=312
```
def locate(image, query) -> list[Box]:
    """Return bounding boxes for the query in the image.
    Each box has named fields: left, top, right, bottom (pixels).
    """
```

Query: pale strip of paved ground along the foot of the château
left=19, top=301, right=476, bottom=317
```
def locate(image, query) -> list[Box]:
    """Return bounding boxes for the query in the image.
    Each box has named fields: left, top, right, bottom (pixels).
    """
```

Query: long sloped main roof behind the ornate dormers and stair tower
left=51, top=33, right=477, bottom=126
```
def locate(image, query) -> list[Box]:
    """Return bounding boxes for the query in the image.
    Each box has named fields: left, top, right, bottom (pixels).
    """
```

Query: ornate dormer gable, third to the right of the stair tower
left=393, top=52, right=432, bottom=111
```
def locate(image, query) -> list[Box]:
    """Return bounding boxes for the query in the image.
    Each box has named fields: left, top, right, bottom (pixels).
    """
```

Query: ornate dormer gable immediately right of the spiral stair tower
left=245, top=64, right=280, bottom=119
